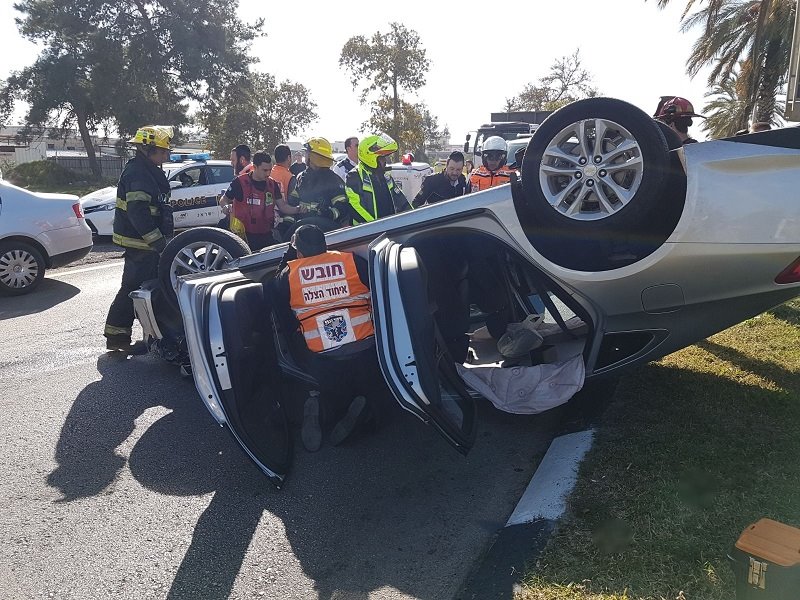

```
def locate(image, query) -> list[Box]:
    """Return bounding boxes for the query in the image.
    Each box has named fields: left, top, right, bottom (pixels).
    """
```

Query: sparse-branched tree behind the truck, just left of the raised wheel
left=505, top=49, right=598, bottom=112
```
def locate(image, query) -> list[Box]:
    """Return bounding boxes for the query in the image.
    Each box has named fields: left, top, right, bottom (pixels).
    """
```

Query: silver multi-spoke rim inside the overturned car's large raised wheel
left=539, top=119, right=644, bottom=221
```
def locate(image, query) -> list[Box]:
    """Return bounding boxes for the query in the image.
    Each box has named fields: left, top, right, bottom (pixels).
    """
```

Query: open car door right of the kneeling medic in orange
left=369, top=237, right=477, bottom=454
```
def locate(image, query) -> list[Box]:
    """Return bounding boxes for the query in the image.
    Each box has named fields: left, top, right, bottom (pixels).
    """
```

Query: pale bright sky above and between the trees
left=0, top=0, right=708, bottom=143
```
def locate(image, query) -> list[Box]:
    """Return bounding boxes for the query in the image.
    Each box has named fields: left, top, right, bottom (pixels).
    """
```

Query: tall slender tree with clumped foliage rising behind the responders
left=339, top=23, right=430, bottom=155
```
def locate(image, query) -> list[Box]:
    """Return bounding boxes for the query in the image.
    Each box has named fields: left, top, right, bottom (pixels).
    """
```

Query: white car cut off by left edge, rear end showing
left=0, top=180, right=92, bottom=296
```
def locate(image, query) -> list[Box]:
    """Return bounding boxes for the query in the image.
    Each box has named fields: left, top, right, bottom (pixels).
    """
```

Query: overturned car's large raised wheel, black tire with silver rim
left=522, top=98, right=671, bottom=271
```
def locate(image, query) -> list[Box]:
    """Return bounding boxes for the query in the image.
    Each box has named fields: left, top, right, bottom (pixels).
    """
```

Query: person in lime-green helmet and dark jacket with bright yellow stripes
left=347, top=133, right=411, bottom=225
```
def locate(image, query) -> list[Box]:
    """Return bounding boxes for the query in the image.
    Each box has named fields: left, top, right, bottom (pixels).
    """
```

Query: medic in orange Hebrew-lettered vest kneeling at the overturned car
left=273, top=225, right=383, bottom=452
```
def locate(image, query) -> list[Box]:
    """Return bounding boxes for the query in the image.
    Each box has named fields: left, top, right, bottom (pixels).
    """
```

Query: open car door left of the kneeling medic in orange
left=178, top=273, right=291, bottom=488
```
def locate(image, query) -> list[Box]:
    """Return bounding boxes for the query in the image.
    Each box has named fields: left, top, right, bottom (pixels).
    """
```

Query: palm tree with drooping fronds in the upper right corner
left=658, top=0, right=796, bottom=129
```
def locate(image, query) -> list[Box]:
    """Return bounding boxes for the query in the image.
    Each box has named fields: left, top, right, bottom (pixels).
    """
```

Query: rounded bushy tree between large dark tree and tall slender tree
left=198, top=73, right=317, bottom=156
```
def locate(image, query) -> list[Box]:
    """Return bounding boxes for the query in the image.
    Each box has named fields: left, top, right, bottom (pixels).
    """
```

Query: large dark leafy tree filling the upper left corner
left=0, top=0, right=263, bottom=175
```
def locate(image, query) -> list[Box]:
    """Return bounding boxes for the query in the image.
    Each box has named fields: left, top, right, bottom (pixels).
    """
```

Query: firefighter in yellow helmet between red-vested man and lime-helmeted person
left=280, top=137, right=349, bottom=237
